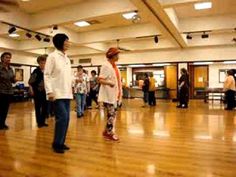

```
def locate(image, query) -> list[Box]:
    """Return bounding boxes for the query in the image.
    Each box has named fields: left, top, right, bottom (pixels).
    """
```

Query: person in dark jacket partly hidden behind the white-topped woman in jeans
left=29, top=55, right=48, bottom=128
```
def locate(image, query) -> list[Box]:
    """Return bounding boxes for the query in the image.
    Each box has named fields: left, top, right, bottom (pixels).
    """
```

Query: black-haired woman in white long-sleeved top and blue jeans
left=44, top=33, right=73, bottom=153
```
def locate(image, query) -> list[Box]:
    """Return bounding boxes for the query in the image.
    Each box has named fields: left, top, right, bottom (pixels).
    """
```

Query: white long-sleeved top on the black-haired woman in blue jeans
left=44, top=50, right=73, bottom=99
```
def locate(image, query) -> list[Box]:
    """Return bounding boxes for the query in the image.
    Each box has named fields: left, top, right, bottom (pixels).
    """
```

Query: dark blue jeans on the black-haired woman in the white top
left=53, top=99, right=70, bottom=147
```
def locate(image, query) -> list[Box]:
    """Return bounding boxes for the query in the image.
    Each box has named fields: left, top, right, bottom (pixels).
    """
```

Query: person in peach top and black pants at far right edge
left=224, top=70, right=236, bottom=110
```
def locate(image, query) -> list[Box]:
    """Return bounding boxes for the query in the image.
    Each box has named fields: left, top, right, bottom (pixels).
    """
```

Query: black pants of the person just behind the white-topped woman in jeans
left=34, top=93, right=47, bottom=125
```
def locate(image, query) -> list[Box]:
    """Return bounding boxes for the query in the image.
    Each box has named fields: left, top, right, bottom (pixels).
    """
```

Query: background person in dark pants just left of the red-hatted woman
left=87, top=70, right=99, bottom=109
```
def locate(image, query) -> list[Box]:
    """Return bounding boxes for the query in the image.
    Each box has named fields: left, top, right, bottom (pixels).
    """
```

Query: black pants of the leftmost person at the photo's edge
left=0, top=93, right=11, bottom=127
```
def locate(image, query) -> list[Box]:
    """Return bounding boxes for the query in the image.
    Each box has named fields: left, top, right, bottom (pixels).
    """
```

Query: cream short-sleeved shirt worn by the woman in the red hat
left=98, top=61, right=122, bottom=105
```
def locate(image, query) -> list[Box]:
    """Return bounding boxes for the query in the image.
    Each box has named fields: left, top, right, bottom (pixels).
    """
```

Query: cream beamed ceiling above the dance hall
left=0, top=0, right=236, bottom=56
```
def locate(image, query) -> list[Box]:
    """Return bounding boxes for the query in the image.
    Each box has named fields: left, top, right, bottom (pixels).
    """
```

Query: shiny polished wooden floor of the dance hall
left=0, top=99, right=236, bottom=177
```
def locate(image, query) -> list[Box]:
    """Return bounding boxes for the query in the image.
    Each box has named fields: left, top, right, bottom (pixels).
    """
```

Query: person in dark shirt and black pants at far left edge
left=0, top=52, right=16, bottom=130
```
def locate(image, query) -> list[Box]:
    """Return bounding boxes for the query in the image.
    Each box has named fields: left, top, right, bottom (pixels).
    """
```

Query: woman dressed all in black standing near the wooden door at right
left=177, top=68, right=189, bottom=108
